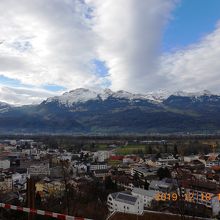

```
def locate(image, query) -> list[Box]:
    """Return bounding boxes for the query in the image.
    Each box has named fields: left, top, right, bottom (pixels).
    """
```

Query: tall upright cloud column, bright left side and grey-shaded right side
left=87, top=0, right=177, bottom=92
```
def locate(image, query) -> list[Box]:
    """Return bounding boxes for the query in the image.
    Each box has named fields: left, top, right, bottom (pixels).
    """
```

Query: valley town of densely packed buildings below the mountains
left=0, top=136, right=220, bottom=220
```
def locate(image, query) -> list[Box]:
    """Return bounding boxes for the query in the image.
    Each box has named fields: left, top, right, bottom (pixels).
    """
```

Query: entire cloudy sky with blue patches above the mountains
left=0, top=0, right=220, bottom=105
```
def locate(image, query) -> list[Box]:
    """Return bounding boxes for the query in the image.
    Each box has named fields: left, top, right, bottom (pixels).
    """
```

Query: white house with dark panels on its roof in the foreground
left=107, top=192, right=144, bottom=215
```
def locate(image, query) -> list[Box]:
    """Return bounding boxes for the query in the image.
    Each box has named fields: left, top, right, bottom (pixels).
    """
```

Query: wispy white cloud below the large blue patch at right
left=160, top=21, right=220, bottom=92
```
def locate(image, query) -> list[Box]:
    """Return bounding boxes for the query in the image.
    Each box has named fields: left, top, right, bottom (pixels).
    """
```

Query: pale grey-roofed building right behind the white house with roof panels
left=131, top=187, right=158, bottom=208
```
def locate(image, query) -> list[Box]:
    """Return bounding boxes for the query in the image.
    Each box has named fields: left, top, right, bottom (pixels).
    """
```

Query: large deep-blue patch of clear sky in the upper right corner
left=162, top=0, right=220, bottom=52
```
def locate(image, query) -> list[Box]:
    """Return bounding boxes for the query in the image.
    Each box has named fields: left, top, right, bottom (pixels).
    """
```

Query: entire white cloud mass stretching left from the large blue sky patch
left=0, top=0, right=176, bottom=94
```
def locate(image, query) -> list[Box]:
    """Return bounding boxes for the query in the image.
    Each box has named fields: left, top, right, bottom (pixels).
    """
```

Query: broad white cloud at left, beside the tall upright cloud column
left=0, top=0, right=99, bottom=89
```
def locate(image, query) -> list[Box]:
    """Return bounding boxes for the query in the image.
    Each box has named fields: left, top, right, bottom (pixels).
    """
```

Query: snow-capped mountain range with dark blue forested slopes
left=0, top=88, right=220, bottom=134
